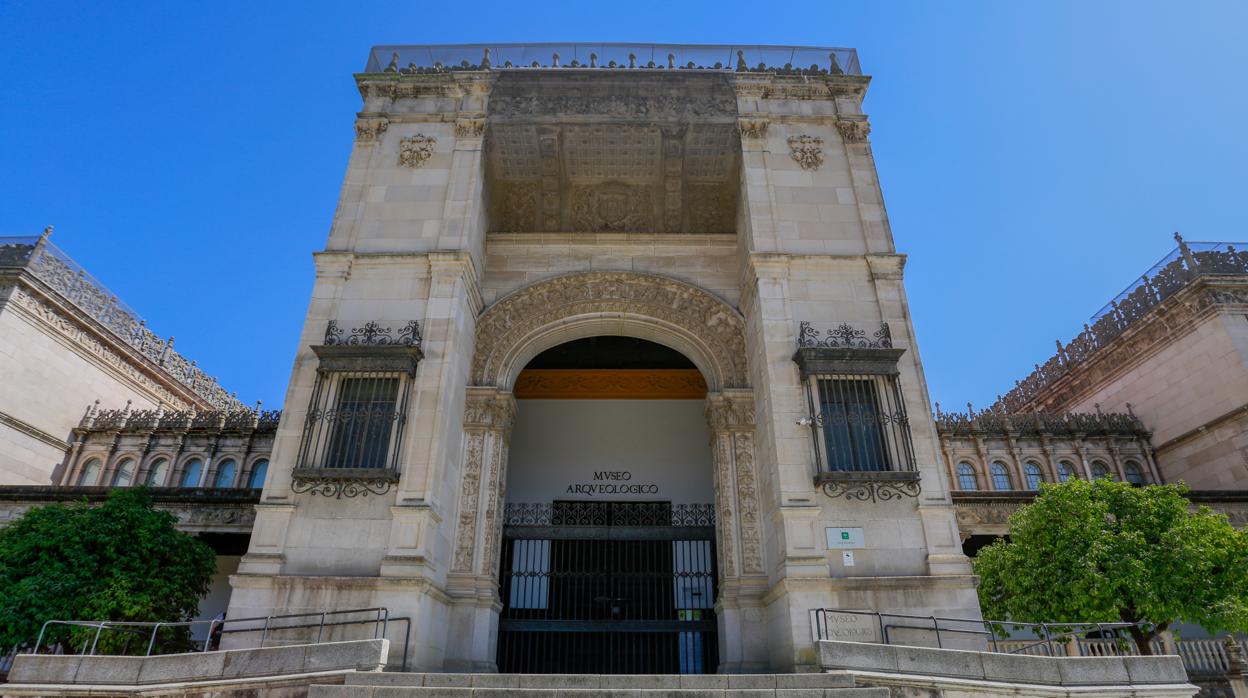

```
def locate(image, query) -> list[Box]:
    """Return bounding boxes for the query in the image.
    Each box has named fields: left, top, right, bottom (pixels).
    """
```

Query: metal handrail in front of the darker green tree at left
left=31, top=607, right=412, bottom=671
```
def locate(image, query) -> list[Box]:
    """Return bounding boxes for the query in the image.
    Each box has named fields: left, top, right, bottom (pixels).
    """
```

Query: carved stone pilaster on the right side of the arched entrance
left=706, top=390, right=768, bottom=672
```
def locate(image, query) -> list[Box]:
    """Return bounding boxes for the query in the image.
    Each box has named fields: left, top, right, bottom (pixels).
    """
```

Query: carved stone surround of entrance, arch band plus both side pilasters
left=446, top=271, right=769, bottom=672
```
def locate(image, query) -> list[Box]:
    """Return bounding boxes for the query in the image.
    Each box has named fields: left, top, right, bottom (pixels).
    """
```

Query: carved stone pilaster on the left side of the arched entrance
left=446, top=387, right=515, bottom=672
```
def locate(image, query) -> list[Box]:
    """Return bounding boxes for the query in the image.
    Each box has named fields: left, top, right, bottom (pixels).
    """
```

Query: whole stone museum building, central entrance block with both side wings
left=0, top=39, right=1248, bottom=673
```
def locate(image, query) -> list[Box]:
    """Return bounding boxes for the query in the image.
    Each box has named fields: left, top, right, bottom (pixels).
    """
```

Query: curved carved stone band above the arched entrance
left=472, top=271, right=749, bottom=392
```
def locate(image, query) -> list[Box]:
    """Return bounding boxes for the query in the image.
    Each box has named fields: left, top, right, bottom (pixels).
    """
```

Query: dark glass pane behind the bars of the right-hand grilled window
left=819, top=380, right=889, bottom=471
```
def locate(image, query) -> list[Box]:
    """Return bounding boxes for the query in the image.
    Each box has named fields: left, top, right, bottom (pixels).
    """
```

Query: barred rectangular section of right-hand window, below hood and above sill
left=810, top=373, right=914, bottom=472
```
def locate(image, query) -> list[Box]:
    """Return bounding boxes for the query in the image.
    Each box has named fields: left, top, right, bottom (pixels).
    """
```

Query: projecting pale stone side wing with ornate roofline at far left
left=0, top=229, right=242, bottom=484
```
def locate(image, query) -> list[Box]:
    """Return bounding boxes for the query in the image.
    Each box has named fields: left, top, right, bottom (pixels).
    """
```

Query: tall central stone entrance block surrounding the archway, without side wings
left=219, top=46, right=978, bottom=672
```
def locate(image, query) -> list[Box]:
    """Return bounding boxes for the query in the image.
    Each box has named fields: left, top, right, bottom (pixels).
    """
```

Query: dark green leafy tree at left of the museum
left=0, top=487, right=216, bottom=648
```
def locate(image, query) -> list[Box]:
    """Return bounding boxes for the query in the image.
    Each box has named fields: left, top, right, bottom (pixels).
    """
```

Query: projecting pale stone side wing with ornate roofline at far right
left=1000, top=239, right=1248, bottom=489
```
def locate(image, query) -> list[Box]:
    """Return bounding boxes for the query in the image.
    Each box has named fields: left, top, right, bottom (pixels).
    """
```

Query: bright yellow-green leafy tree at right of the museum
left=975, top=478, right=1248, bottom=654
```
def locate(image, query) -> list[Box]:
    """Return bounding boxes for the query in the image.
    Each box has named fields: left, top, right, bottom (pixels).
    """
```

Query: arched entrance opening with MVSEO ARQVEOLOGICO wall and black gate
left=497, top=336, right=719, bottom=673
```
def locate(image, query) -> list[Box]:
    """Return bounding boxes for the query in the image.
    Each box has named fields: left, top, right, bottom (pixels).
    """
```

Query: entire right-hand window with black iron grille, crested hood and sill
left=794, top=322, right=919, bottom=501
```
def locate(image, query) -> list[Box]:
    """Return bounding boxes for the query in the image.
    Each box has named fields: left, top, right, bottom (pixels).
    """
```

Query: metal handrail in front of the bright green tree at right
left=814, top=608, right=1142, bottom=657
